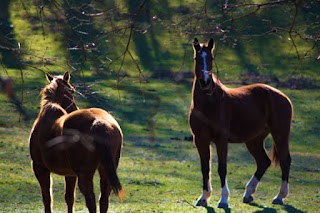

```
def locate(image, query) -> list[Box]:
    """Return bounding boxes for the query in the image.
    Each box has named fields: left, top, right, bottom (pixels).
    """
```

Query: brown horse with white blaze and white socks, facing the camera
left=189, top=38, right=293, bottom=208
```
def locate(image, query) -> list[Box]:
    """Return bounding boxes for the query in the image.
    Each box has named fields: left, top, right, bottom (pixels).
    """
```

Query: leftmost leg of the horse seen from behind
left=32, top=162, right=51, bottom=213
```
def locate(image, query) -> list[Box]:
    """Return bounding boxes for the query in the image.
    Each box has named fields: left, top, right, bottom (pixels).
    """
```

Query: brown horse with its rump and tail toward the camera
left=29, top=72, right=123, bottom=213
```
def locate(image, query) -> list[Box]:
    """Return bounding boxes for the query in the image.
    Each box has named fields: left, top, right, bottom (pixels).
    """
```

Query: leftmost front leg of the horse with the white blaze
left=193, top=136, right=212, bottom=206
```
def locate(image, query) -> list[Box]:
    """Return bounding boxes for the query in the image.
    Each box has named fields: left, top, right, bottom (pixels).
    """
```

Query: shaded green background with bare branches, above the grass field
left=0, top=0, right=320, bottom=89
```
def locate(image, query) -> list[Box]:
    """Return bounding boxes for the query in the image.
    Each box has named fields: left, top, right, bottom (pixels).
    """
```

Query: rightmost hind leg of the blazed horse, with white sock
left=272, top=133, right=291, bottom=205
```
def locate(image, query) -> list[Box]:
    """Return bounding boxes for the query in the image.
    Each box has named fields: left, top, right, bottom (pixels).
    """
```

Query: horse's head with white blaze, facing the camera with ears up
left=193, top=38, right=215, bottom=90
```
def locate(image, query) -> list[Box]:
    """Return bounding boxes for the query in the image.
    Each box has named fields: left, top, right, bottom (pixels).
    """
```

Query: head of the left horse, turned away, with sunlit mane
left=43, top=72, right=78, bottom=113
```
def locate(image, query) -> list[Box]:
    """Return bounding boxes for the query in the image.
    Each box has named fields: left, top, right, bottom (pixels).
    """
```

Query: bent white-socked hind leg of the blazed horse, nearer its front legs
left=243, top=134, right=271, bottom=203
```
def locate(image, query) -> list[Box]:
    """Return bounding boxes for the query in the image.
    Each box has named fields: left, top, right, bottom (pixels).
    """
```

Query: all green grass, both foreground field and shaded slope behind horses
left=0, top=0, right=320, bottom=213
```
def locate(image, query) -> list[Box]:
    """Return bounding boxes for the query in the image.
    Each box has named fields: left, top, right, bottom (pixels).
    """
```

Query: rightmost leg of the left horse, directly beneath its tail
left=99, top=166, right=111, bottom=213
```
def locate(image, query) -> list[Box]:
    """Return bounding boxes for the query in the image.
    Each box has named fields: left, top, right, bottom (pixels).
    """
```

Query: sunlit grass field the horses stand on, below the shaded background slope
left=0, top=76, right=320, bottom=212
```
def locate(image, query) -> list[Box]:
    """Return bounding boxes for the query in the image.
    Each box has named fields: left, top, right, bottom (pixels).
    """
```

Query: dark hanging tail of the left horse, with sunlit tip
left=92, top=125, right=125, bottom=200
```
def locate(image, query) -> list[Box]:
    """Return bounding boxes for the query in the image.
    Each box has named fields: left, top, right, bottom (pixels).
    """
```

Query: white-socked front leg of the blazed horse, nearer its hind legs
left=216, top=140, right=230, bottom=208
